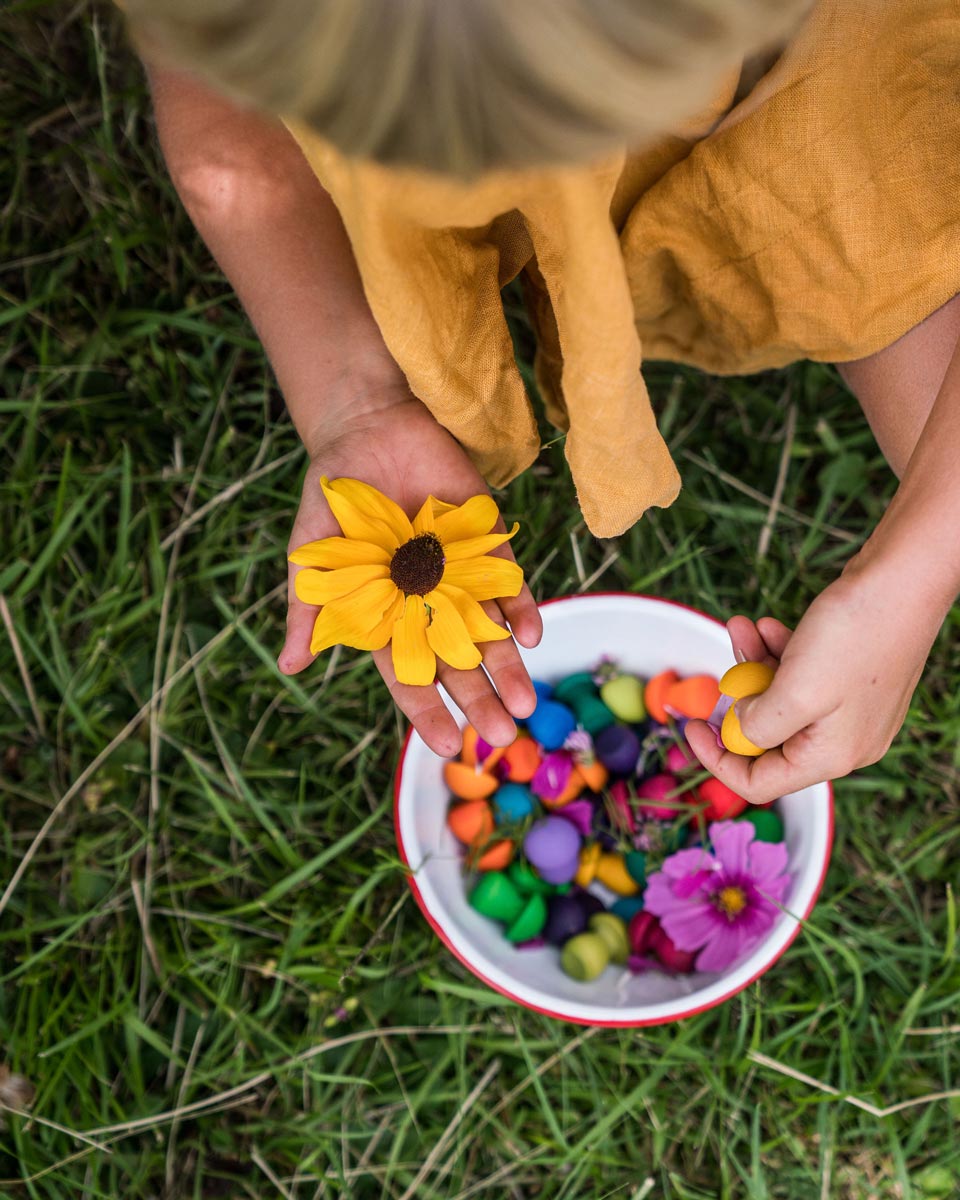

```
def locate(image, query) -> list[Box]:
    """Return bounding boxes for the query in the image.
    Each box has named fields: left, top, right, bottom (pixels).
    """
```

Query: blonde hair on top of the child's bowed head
left=126, top=0, right=809, bottom=178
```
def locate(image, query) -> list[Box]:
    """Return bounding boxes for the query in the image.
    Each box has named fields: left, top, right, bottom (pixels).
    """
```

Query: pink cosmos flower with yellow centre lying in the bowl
left=643, top=821, right=791, bottom=971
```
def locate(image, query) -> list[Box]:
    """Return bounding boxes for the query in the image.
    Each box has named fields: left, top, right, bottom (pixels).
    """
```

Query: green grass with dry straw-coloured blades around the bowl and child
left=0, top=2, right=960, bottom=1200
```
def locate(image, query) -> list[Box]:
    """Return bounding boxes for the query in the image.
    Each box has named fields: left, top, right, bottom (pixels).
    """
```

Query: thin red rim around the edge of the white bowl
left=394, top=592, right=834, bottom=1028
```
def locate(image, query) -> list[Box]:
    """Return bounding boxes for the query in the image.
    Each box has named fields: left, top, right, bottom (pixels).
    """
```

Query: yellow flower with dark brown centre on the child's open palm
left=290, top=476, right=523, bottom=684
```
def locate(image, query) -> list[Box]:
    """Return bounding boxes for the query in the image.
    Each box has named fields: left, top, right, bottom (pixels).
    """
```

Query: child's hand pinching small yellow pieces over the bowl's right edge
left=686, top=564, right=944, bottom=804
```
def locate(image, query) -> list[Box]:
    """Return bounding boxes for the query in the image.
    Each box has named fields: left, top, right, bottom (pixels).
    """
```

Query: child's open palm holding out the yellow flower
left=278, top=389, right=544, bottom=756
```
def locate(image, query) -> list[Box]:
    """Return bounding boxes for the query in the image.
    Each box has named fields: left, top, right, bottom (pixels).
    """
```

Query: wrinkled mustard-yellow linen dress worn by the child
left=288, top=0, right=960, bottom=538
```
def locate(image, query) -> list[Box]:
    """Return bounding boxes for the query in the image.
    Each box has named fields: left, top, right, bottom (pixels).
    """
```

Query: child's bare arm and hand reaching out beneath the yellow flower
left=149, top=67, right=542, bottom=754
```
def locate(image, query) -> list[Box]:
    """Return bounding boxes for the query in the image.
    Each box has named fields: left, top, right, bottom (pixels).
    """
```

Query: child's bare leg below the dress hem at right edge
left=836, top=295, right=960, bottom=476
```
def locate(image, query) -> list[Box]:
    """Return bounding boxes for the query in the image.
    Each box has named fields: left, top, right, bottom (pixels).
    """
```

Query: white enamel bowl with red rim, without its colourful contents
left=394, top=593, right=833, bottom=1025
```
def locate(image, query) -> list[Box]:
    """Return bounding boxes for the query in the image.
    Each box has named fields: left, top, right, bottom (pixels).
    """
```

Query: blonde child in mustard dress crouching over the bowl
left=127, top=0, right=960, bottom=802
